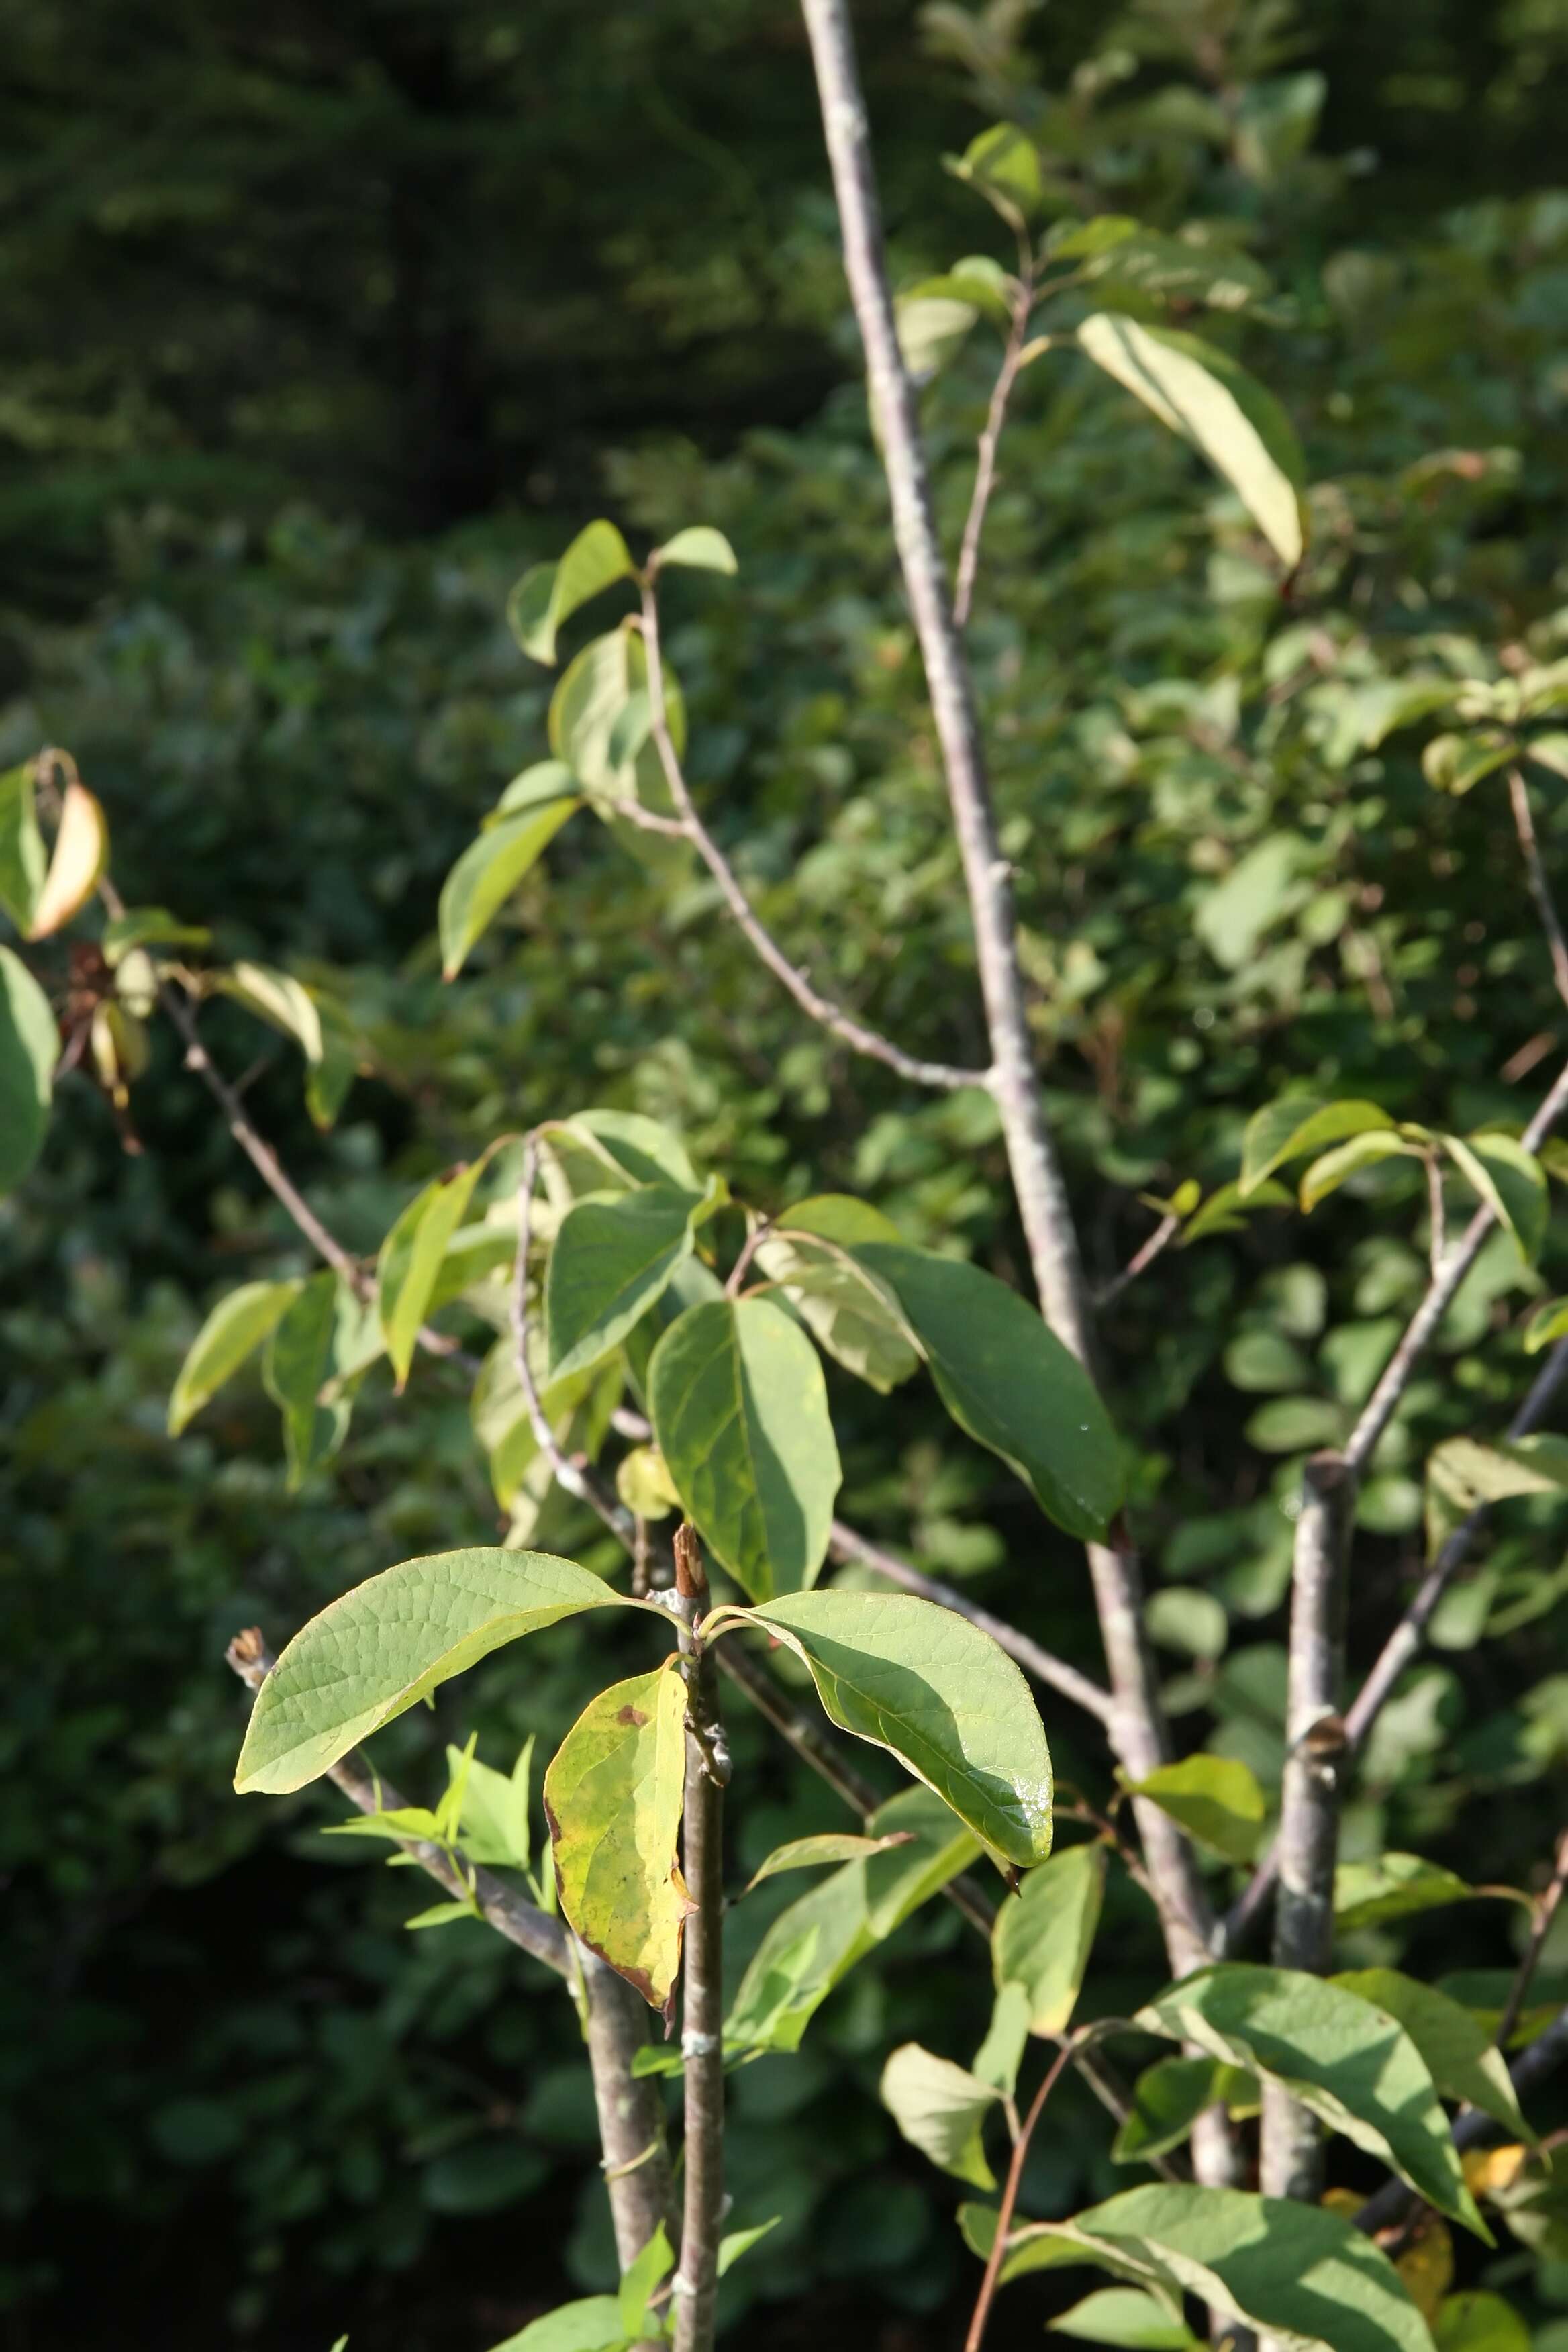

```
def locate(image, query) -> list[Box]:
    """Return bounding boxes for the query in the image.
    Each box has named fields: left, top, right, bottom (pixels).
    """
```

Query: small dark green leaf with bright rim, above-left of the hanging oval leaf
left=546, top=1183, right=717, bottom=1381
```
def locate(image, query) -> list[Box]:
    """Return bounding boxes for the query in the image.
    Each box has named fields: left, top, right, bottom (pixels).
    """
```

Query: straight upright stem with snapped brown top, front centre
left=675, top=1524, right=726, bottom=2352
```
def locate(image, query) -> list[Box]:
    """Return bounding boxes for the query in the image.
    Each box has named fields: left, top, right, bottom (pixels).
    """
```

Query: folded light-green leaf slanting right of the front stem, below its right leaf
left=724, top=1787, right=980, bottom=2051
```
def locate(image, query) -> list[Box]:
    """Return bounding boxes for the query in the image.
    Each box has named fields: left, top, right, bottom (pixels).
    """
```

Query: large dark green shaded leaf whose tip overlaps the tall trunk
left=856, top=1242, right=1124, bottom=1540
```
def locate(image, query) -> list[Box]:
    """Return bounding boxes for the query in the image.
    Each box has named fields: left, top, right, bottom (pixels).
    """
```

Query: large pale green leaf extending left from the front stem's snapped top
left=235, top=1550, right=663, bottom=1795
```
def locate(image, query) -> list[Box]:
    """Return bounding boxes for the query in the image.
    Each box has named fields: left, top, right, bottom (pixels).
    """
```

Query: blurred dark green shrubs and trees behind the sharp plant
left=0, top=0, right=1568, bottom=2352
